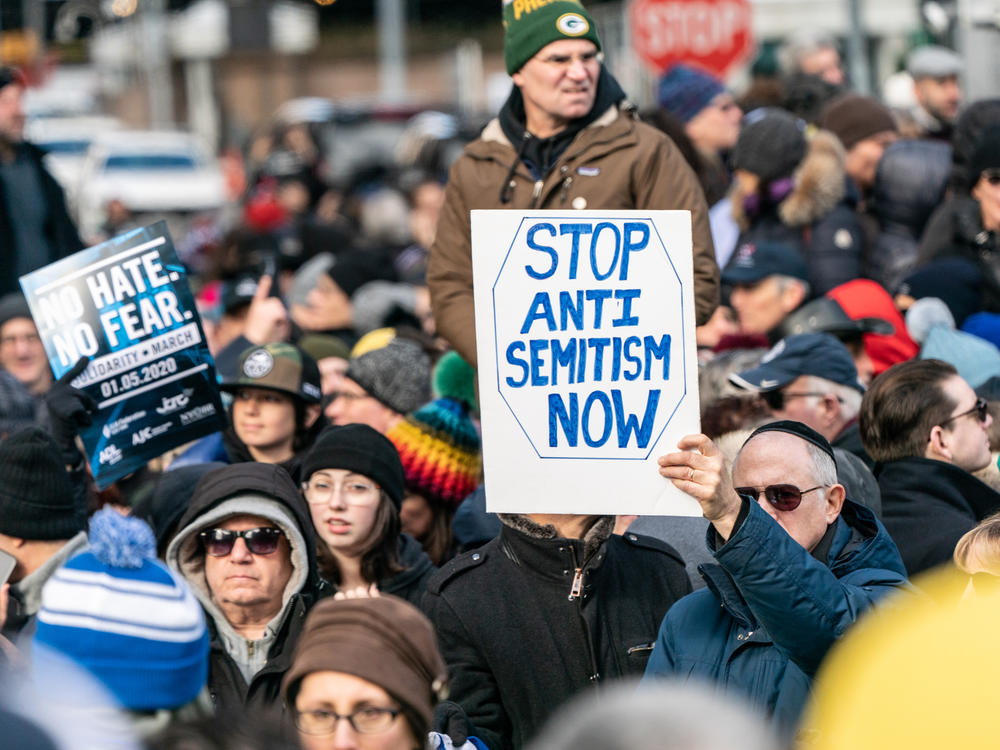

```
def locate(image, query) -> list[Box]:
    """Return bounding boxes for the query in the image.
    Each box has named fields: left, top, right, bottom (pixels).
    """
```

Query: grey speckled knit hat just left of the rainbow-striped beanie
left=347, top=338, right=431, bottom=414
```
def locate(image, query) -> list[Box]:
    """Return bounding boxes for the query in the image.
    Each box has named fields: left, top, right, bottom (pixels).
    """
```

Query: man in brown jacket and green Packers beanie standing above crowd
left=427, top=0, right=719, bottom=365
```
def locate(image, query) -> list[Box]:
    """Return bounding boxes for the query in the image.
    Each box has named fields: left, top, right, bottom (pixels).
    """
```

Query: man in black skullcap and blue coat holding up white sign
left=644, top=420, right=906, bottom=732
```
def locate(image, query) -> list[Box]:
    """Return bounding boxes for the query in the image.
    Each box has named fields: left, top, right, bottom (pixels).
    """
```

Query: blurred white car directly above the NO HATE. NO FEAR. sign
left=73, top=130, right=226, bottom=237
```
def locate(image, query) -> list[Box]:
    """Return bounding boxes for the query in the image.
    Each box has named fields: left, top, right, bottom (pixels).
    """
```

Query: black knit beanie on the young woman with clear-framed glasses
left=302, top=424, right=404, bottom=510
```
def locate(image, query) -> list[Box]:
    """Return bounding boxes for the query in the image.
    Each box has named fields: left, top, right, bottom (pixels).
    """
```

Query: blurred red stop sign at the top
left=629, top=0, right=754, bottom=77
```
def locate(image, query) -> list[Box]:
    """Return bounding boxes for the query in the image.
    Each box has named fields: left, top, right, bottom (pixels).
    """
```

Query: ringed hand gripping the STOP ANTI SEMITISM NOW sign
left=657, top=434, right=740, bottom=539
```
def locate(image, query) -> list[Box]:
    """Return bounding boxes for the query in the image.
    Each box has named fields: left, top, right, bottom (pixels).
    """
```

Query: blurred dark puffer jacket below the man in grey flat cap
left=865, top=141, right=951, bottom=292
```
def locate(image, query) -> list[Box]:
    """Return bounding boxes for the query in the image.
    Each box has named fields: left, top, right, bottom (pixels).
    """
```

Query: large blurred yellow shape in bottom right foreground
left=798, top=567, right=1000, bottom=750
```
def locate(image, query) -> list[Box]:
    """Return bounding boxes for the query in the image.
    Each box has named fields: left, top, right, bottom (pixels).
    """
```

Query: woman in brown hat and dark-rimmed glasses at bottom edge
left=282, top=595, right=447, bottom=750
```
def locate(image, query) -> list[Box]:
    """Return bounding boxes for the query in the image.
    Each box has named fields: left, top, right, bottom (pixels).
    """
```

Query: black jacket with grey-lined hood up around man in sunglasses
left=167, top=463, right=332, bottom=712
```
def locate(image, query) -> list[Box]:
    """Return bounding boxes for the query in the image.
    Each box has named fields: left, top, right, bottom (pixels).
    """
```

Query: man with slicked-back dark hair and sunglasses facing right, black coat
left=860, top=359, right=1000, bottom=575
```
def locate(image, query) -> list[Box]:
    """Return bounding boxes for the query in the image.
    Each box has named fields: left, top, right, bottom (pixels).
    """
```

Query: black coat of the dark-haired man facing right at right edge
left=875, top=458, right=1000, bottom=576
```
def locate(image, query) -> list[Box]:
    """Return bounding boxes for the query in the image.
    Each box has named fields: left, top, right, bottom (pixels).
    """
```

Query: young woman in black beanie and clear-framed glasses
left=302, top=424, right=434, bottom=605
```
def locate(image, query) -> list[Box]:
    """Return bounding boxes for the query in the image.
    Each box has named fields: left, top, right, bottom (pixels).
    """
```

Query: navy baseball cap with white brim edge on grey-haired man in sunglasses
left=729, top=333, right=865, bottom=393
